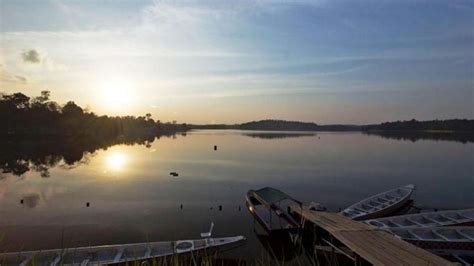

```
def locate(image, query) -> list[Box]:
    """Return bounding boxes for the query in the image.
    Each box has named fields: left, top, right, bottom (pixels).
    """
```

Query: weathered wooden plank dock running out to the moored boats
left=290, top=206, right=455, bottom=265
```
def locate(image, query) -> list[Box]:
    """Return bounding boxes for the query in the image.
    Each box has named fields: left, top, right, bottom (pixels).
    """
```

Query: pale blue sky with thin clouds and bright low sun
left=0, top=0, right=474, bottom=124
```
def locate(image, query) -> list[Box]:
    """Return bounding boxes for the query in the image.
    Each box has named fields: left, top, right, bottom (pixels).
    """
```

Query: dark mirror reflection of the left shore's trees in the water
left=0, top=134, right=181, bottom=179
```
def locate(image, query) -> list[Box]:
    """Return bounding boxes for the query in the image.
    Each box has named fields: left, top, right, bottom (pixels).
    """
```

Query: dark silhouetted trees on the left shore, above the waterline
left=0, top=91, right=187, bottom=140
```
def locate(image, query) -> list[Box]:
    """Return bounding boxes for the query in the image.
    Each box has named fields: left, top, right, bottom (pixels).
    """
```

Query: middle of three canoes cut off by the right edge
left=386, top=226, right=474, bottom=250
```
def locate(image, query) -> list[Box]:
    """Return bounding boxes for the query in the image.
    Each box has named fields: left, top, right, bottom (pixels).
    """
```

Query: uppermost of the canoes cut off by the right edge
left=364, top=209, right=474, bottom=229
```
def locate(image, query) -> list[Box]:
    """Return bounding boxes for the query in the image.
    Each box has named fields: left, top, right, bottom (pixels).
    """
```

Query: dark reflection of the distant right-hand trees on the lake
left=364, top=130, right=474, bottom=143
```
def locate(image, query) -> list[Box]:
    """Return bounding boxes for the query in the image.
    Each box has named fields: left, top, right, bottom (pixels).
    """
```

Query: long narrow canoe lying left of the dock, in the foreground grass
left=0, top=236, right=245, bottom=266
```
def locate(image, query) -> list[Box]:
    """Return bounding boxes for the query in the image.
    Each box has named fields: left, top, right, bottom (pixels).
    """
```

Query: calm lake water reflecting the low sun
left=0, top=130, right=474, bottom=259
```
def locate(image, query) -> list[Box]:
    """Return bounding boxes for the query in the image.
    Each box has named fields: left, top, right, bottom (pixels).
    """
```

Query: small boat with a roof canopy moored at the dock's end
left=246, top=187, right=303, bottom=233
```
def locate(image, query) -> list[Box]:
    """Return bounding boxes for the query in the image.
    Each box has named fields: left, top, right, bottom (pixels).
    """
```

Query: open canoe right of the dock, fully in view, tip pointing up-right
left=340, top=184, right=415, bottom=221
